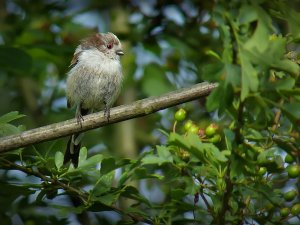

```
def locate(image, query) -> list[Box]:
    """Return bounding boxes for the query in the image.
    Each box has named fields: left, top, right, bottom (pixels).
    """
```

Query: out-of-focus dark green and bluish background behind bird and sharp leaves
left=0, top=0, right=299, bottom=225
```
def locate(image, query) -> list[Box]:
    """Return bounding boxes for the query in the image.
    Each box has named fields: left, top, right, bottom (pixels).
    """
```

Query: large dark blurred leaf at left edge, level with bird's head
left=0, top=46, right=32, bottom=75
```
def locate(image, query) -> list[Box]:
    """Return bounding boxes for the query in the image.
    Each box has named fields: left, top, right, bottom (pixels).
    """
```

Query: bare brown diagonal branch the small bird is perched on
left=0, top=82, right=217, bottom=153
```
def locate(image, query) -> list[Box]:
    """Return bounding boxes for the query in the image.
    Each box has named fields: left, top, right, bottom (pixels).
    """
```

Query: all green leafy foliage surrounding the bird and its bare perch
left=0, top=0, right=300, bottom=225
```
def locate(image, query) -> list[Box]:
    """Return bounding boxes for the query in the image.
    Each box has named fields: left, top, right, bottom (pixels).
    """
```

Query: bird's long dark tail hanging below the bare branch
left=64, top=133, right=83, bottom=168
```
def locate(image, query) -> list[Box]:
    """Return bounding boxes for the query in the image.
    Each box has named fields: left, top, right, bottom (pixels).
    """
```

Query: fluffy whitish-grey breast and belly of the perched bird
left=66, top=49, right=123, bottom=110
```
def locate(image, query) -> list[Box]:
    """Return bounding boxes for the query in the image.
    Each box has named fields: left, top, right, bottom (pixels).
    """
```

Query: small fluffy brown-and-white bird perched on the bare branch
left=64, top=33, right=124, bottom=168
